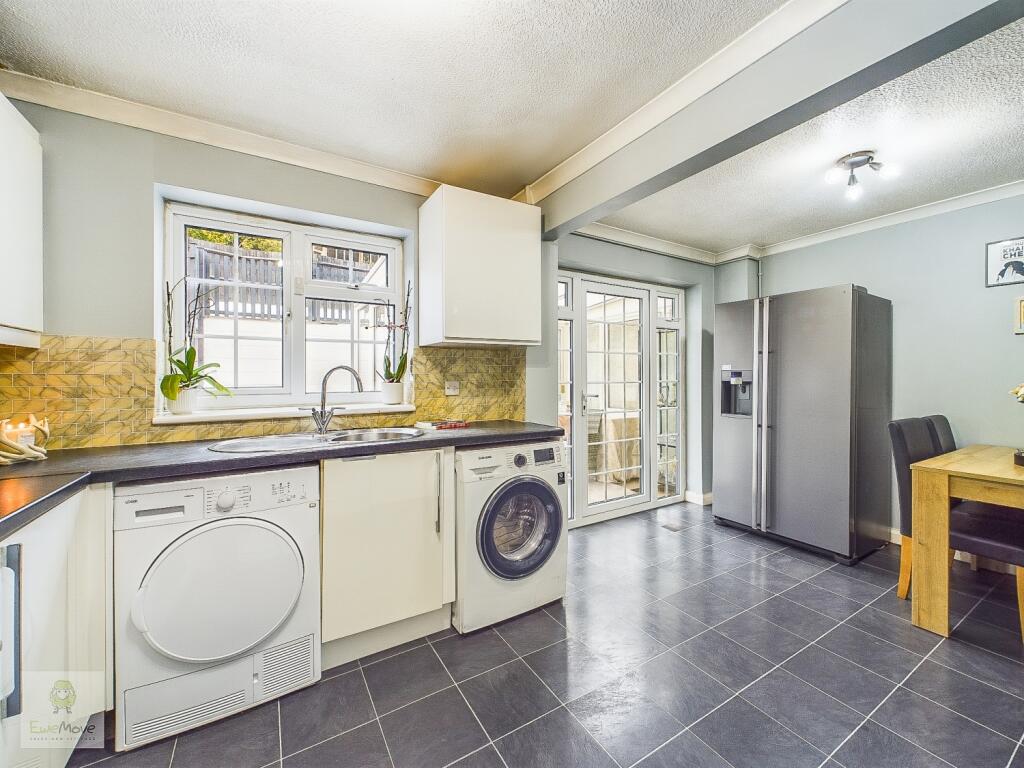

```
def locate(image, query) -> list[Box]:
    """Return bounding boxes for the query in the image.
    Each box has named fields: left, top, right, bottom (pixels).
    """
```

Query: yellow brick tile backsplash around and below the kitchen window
left=0, top=336, right=526, bottom=449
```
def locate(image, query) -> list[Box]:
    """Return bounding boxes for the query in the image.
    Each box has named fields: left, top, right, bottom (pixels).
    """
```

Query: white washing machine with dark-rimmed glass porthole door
left=452, top=442, right=568, bottom=633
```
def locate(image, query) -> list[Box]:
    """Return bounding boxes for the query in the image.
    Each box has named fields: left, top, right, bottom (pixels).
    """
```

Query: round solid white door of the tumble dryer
left=131, top=517, right=305, bottom=664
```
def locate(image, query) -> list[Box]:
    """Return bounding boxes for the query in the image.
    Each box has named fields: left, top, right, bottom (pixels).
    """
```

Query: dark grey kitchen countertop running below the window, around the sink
left=0, top=421, right=564, bottom=540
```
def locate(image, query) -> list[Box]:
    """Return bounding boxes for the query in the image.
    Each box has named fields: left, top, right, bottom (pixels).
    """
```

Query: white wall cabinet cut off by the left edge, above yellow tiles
left=0, top=94, right=43, bottom=347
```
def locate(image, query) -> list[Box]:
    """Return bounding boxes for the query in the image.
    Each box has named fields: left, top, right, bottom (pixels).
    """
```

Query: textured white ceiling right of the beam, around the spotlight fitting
left=602, top=22, right=1024, bottom=253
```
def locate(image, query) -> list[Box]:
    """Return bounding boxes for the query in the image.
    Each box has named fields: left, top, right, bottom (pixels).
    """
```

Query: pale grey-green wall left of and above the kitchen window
left=13, top=101, right=423, bottom=338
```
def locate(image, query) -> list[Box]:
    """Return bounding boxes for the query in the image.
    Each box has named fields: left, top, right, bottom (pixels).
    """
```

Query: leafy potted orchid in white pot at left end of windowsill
left=160, top=278, right=231, bottom=415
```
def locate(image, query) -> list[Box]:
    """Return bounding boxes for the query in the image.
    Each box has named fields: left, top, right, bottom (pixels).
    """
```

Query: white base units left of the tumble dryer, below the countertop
left=0, top=492, right=106, bottom=768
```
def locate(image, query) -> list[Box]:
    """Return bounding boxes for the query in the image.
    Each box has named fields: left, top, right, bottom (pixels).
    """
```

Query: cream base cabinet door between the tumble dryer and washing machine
left=321, top=449, right=455, bottom=643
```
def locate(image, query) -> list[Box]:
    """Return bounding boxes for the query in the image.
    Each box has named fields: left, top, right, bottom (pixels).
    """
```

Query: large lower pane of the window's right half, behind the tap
left=305, top=299, right=394, bottom=392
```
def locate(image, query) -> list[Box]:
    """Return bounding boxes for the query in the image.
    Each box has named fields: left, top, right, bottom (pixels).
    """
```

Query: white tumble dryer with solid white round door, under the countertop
left=114, top=467, right=321, bottom=750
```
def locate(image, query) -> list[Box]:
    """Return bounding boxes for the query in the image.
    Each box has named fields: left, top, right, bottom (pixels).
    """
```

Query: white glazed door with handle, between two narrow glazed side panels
left=574, top=281, right=650, bottom=516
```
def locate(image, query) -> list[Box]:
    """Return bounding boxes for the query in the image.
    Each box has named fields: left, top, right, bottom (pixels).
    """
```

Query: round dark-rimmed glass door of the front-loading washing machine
left=477, top=475, right=562, bottom=580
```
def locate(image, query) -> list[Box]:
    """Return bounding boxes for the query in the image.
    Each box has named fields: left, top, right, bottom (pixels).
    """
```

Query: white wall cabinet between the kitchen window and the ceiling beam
left=419, top=184, right=542, bottom=346
